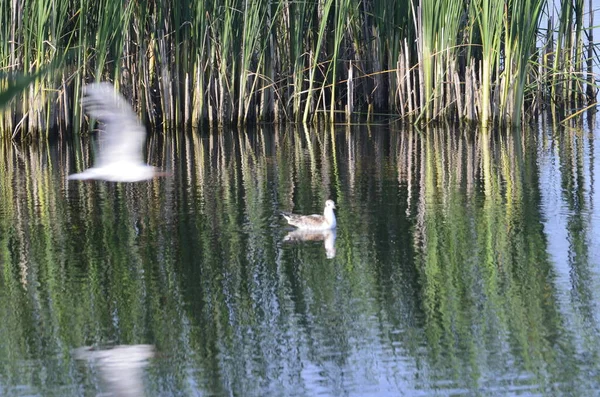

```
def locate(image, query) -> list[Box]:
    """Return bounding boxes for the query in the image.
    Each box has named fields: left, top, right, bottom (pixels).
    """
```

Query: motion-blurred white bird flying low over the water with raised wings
left=69, top=83, right=165, bottom=182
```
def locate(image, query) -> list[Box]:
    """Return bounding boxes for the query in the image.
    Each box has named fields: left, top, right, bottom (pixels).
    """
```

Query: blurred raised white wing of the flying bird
left=82, top=83, right=146, bottom=167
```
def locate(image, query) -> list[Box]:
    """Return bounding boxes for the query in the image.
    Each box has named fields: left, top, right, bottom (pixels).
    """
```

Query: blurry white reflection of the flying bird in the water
left=73, top=345, right=154, bottom=397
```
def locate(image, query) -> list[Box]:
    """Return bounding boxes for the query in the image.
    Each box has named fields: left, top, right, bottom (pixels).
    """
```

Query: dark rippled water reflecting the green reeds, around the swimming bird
left=0, top=125, right=600, bottom=396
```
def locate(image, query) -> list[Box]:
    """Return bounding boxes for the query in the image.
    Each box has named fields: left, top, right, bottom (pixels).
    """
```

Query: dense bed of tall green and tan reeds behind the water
left=0, top=0, right=597, bottom=136
